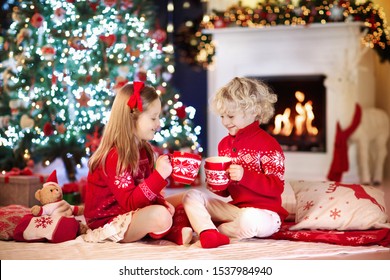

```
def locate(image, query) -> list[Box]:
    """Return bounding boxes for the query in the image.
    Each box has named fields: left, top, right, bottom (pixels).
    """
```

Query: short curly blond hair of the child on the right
left=211, top=77, right=277, bottom=124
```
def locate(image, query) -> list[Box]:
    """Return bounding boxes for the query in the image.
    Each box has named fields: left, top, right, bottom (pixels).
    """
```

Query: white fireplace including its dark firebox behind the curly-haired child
left=205, top=22, right=375, bottom=182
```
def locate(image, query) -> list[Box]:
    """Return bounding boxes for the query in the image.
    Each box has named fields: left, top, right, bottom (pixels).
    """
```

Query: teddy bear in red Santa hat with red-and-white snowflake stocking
left=14, top=171, right=88, bottom=243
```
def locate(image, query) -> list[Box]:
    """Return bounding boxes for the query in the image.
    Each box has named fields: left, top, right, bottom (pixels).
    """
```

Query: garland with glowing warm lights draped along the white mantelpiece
left=177, top=0, right=390, bottom=68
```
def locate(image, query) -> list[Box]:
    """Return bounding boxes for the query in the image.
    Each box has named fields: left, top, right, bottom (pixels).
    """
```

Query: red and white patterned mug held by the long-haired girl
left=170, top=151, right=202, bottom=185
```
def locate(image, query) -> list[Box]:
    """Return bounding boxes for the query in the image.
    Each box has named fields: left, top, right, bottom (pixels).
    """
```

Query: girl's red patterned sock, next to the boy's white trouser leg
left=164, top=204, right=192, bottom=245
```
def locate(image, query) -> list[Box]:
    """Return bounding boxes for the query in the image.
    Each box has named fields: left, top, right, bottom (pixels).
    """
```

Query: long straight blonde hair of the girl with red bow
left=88, top=84, right=160, bottom=175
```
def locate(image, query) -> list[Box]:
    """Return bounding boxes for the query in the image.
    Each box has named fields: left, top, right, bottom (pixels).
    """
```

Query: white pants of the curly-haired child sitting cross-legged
left=183, top=190, right=281, bottom=239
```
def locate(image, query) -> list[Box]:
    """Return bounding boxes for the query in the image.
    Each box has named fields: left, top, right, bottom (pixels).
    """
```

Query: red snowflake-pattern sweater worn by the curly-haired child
left=218, top=121, right=288, bottom=221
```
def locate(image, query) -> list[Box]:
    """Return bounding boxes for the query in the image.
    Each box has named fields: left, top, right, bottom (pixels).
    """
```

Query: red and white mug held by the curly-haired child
left=204, top=156, right=232, bottom=191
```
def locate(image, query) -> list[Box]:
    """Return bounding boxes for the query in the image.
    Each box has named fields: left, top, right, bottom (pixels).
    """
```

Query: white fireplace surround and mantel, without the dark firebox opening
left=206, top=22, right=375, bottom=182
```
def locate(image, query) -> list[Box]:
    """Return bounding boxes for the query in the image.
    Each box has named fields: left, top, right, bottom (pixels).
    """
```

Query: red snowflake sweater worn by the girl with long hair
left=84, top=148, right=167, bottom=229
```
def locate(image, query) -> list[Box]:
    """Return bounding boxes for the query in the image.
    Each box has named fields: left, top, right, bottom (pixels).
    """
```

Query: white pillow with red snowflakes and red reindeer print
left=290, top=181, right=390, bottom=230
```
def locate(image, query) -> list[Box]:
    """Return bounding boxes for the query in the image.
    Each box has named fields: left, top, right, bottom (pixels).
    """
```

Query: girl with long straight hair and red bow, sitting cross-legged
left=83, top=82, right=192, bottom=243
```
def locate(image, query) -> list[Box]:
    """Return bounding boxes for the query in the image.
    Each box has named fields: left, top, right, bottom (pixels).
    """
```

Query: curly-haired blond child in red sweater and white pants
left=183, top=77, right=288, bottom=248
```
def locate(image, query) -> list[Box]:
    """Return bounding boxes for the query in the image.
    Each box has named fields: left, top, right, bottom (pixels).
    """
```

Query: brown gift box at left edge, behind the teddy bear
left=0, top=174, right=47, bottom=207
